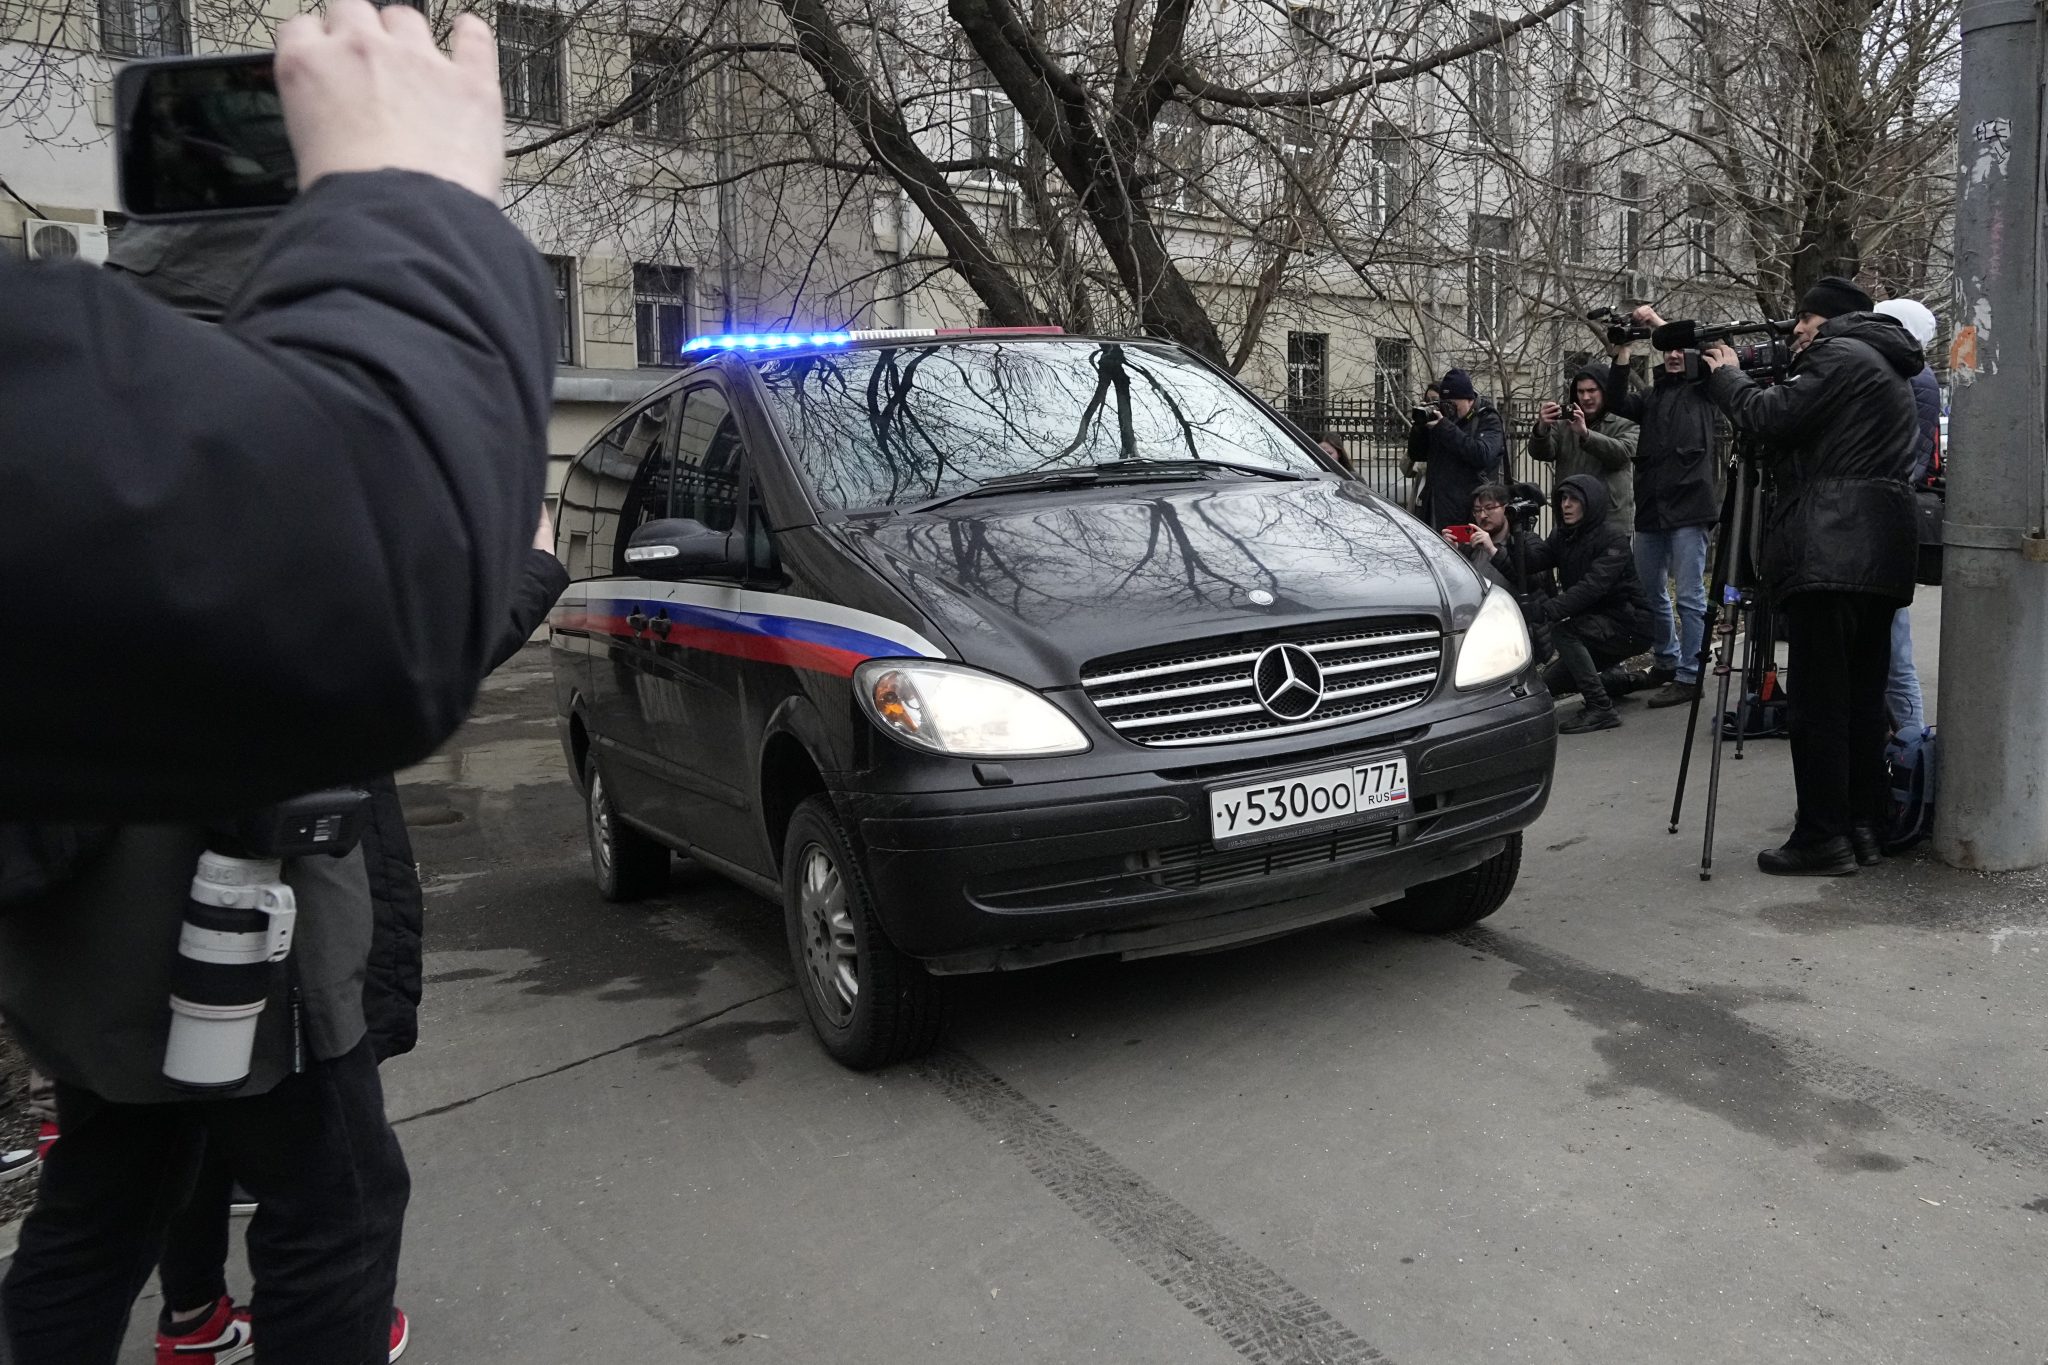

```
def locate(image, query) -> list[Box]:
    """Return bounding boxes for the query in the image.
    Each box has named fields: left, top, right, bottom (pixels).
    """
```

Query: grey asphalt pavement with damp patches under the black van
left=119, top=600, right=2048, bottom=1365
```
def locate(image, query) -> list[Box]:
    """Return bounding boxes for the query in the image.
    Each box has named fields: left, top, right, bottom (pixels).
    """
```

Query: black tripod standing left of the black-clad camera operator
left=1671, top=440, right=1778, bottom=882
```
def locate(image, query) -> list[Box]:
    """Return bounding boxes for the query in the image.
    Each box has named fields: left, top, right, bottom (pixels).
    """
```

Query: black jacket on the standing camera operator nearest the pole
left=1706, top=313, right=1925, bottom=606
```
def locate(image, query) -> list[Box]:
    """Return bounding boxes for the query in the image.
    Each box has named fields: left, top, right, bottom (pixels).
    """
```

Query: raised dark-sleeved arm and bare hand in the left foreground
left=0, top=0, right=555, bottom=821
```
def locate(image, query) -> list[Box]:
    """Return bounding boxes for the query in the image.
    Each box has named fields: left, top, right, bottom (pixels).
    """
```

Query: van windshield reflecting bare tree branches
left=758, top=340, right=1321, bottom=510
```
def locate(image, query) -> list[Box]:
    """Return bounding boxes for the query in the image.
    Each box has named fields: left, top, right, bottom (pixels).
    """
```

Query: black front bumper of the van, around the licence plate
left=834, top=688, right=1556, bottom=972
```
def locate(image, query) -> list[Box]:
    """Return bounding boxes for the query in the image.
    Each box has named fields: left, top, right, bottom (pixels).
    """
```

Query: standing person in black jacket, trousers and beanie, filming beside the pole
left=1702, top=276, right=1923, bottom=876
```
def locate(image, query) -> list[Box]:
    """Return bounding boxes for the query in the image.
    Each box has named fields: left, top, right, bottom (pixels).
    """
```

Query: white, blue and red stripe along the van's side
left=549, top=579, right=946, bottom=677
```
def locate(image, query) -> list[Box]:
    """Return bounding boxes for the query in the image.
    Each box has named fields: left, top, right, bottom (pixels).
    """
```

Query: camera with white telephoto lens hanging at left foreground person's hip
left=164, top=788, right=369, bottom=1091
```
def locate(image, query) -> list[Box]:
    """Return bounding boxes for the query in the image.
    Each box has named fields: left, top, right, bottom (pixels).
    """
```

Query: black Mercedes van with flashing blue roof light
left=551, top=329, right=1556, bottom=1068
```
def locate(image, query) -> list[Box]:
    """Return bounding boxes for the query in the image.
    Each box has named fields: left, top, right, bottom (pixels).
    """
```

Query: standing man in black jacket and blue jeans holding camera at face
left=1606, top=303, right=1720, bottom=706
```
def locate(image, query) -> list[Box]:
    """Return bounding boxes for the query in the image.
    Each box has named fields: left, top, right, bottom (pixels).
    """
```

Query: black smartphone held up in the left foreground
left=115, top=53, right=299, bottom=219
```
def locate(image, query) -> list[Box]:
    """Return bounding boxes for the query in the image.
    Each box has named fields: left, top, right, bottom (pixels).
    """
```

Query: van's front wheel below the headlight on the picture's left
left=782, top=796, right=952, bottom=1070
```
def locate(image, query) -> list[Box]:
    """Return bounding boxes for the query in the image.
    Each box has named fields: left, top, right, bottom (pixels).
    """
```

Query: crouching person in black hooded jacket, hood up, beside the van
left=1473, top=475, right=1653, bottom=735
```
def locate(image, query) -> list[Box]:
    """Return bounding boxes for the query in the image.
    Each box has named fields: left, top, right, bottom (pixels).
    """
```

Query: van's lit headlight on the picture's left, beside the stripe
left=854, top=659, right=1087, bottom=759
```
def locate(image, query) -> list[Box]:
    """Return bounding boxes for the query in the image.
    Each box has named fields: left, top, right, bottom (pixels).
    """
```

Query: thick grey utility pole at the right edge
left=1933, top=0, right=2048, bottom=872
